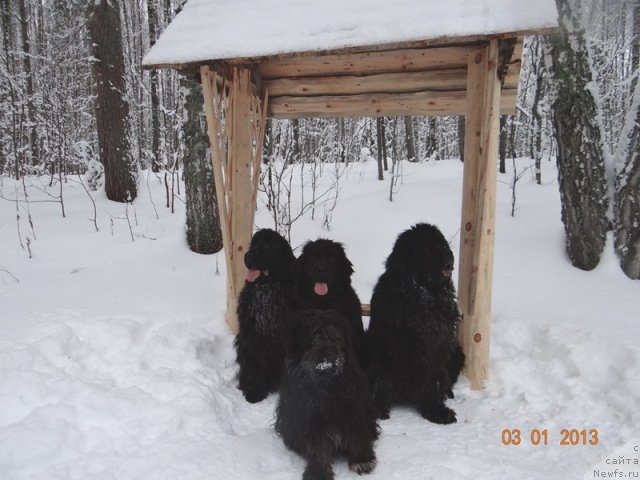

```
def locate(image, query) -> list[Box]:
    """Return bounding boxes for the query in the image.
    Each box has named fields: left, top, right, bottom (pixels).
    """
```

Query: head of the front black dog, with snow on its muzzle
left=288, top=310, right=350, bottom=379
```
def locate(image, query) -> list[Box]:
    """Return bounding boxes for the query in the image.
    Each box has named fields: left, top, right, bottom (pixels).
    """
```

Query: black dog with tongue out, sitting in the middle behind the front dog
left=296, top=238, right=366, bottom=362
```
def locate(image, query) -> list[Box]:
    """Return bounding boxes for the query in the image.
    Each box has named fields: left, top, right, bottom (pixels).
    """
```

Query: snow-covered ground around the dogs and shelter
left=0, top=160, right=640, bottom=480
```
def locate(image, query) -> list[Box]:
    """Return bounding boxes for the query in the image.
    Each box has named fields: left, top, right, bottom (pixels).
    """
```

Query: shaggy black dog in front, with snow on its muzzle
left=275, top=309, right=378, bottom=480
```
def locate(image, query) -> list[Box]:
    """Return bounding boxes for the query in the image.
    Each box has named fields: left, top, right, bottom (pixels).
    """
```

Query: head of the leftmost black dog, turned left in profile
left=244, top=228, right=296, bottom=283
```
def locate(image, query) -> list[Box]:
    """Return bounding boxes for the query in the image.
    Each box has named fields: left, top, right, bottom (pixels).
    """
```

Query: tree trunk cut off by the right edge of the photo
left=613, top=4, right=640, bottom=280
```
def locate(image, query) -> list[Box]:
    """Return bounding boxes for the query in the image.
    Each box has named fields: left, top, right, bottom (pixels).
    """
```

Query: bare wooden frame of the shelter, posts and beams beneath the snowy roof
left=145, top=12, right=556, bottom=389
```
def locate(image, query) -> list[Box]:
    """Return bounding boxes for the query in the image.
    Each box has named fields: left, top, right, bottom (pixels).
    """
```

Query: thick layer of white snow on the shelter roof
left=142, top=0, right=557, bottom=65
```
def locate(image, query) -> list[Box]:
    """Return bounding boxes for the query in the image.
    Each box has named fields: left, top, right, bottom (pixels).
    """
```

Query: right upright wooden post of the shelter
left=458, top=40, right=500, bottom=390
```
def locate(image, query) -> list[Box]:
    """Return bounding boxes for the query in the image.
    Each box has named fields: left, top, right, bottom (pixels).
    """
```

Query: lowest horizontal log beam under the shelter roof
left=269, top=90, right=516, bottom=118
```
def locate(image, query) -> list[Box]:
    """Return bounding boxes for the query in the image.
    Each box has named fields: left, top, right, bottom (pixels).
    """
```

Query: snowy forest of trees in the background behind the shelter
left=0, top=0, right=640, bottom=278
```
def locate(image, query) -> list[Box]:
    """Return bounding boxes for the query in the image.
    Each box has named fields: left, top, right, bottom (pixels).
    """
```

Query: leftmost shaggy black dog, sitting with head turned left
left=235, top=229, right=296, bottom=403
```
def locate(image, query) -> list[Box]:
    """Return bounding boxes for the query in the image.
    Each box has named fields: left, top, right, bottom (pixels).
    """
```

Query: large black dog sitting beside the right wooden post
left=367, top=223, right=464, bottom=424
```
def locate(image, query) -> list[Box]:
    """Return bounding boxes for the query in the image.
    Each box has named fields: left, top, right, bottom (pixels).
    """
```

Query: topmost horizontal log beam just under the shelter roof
left=258, top=46, right=469, bottom=80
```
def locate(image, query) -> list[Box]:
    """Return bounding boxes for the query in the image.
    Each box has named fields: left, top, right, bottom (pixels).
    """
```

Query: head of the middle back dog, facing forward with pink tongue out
left=297, top=238, right=353, bottom=304
